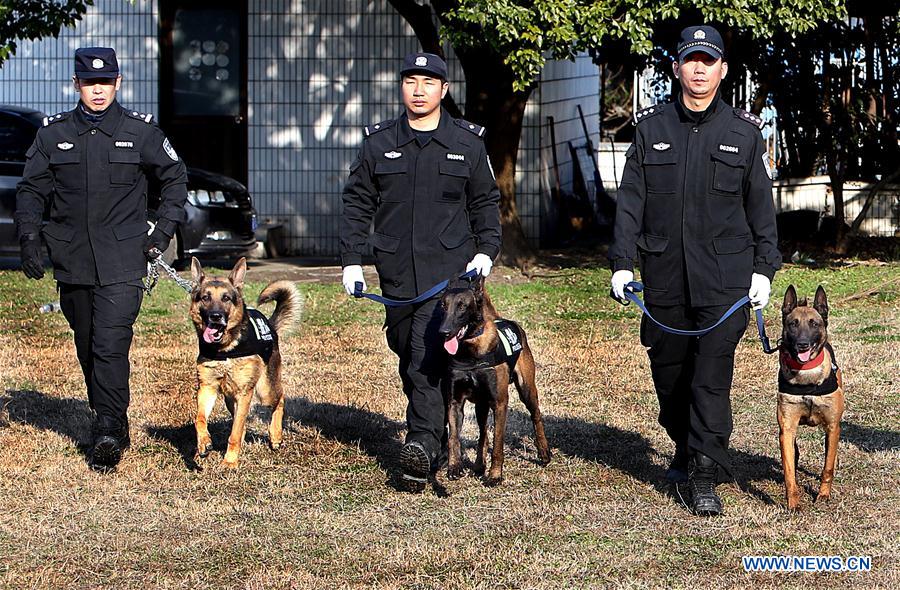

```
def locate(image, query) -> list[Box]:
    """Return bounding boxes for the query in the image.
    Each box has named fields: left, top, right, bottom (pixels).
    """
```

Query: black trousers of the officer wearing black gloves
left=58, top=283, right=144, bottom=430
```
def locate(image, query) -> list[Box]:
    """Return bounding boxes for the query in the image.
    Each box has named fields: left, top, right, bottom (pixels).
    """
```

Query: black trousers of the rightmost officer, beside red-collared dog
left=641, top=305, right=750, bottom=476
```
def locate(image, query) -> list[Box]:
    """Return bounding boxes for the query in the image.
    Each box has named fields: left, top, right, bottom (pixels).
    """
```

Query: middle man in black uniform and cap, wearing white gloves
left=341, top=53, right=500, bottom=490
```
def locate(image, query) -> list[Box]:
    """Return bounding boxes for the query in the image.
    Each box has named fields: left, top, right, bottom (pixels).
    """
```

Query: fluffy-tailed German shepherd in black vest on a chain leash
left=190, top=258, right=303, bottom=468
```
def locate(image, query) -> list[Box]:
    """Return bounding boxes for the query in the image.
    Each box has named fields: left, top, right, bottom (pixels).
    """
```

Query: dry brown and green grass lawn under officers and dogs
left=0, top=265, right=900, bottom=588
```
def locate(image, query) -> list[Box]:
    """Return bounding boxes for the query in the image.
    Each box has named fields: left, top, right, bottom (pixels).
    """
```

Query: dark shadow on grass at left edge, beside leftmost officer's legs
left=0, top=389, right=93, bottom=461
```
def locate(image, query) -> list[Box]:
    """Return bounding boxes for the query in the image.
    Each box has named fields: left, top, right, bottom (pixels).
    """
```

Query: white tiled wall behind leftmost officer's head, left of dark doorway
left=0, top=0, right=159, bottom=119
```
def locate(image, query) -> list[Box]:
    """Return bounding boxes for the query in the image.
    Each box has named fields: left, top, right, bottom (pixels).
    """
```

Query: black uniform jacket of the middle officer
left=341, top=111, right=500, bottom=298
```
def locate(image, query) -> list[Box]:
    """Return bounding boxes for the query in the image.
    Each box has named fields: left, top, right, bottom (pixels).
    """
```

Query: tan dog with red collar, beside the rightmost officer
left=778, top=285, right=844, bottom=510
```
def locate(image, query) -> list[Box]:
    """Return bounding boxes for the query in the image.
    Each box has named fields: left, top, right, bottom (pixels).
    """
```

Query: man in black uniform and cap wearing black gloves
left=15, top=47, right=187, bottom=468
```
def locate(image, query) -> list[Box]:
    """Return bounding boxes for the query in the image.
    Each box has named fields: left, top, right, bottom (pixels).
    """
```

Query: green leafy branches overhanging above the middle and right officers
left=434, top=0, right=846, bottom=91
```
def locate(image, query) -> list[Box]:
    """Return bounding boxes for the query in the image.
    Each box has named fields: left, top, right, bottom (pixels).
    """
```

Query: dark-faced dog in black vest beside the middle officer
left=439, top=277, right=550, bottom=485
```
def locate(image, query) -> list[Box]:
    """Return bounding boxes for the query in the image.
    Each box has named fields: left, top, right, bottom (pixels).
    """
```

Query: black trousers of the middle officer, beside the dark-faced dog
left=384, top=298, right=447, bottom=457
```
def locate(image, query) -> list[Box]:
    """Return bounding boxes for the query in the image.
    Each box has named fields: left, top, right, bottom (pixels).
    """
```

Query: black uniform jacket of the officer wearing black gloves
left=16, top=102, right=187, bottom=285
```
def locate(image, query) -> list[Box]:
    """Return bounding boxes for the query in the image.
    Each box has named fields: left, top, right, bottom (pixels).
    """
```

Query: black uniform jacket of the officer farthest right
left=609, top=97, right=781, bottom=306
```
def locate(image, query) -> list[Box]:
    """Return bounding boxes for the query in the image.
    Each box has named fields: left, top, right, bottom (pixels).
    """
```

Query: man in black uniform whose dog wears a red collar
left=609, top=26, right=781, bottom=515
